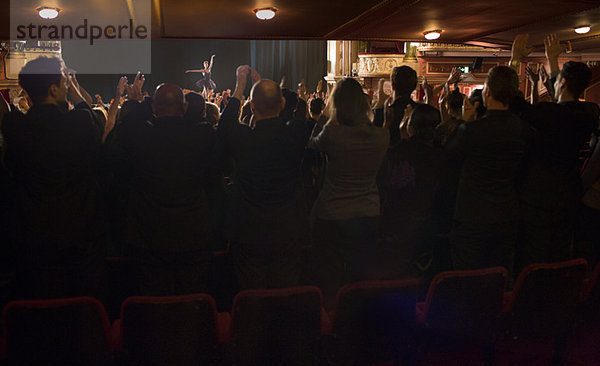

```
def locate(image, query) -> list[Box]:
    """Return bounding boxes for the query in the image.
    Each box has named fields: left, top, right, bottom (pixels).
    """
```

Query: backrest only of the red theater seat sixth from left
left=509, top=259, right=587, bottom=337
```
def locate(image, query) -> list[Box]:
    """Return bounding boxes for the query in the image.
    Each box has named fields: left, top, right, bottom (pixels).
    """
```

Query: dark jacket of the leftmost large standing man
left=2, top=103, right=107, bottom=249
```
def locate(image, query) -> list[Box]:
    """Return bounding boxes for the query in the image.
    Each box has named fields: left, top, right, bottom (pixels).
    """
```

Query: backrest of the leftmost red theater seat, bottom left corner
left=3, top=297, right=110, bottom=365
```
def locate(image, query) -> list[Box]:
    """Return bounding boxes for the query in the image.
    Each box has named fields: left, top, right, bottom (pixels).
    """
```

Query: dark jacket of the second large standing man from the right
left=446, top=110, right=528, bottom=224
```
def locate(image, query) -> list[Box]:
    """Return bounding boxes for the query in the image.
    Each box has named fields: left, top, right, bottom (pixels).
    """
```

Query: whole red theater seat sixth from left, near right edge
left=495, top=259, right=587, bottom=365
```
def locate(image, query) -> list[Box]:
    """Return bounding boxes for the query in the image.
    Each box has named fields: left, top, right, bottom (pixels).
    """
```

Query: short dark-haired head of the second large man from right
left=482, top=66, right=519, bottom=109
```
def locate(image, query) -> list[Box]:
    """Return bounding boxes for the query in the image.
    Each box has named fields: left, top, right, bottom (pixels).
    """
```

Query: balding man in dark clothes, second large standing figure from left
left=110, top=84, right=220, bottom=295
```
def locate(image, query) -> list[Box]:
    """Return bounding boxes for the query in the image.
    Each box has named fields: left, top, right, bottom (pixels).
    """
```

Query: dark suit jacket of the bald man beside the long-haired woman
left=218, top=98, right=309, bottom=251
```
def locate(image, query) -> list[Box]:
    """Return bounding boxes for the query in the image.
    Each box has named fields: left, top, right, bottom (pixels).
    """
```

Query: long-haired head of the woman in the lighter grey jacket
left=330, top=78, right=371, bottom=126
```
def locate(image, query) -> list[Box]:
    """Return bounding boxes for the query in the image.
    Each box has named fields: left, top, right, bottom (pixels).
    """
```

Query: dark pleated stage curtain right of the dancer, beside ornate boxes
left=250, top=40, right=327, bottom=92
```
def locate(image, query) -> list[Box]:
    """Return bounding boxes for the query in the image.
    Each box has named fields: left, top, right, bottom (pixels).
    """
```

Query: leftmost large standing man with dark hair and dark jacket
left=2, top=57, right=107, bottom=298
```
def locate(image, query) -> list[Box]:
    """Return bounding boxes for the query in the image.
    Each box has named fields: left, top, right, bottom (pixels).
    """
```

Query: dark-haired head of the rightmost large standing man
left=554, top=61, right=592, bottom=100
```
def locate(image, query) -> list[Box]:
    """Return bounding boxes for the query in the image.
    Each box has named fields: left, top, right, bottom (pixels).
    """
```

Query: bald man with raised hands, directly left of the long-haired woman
left=219, top=66, right=308, bottom=289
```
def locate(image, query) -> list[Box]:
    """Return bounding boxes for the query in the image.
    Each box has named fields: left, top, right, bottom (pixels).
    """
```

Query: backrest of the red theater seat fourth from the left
left=328, top=280, right=418, bottom=364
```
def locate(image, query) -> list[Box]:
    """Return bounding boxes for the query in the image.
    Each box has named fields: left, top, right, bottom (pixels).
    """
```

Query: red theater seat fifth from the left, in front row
left=417, top=267, right=508, bottom=365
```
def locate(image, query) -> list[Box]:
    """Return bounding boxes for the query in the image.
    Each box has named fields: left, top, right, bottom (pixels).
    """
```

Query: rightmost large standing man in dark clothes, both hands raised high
left=511, top=35, right=600, bottom=269
